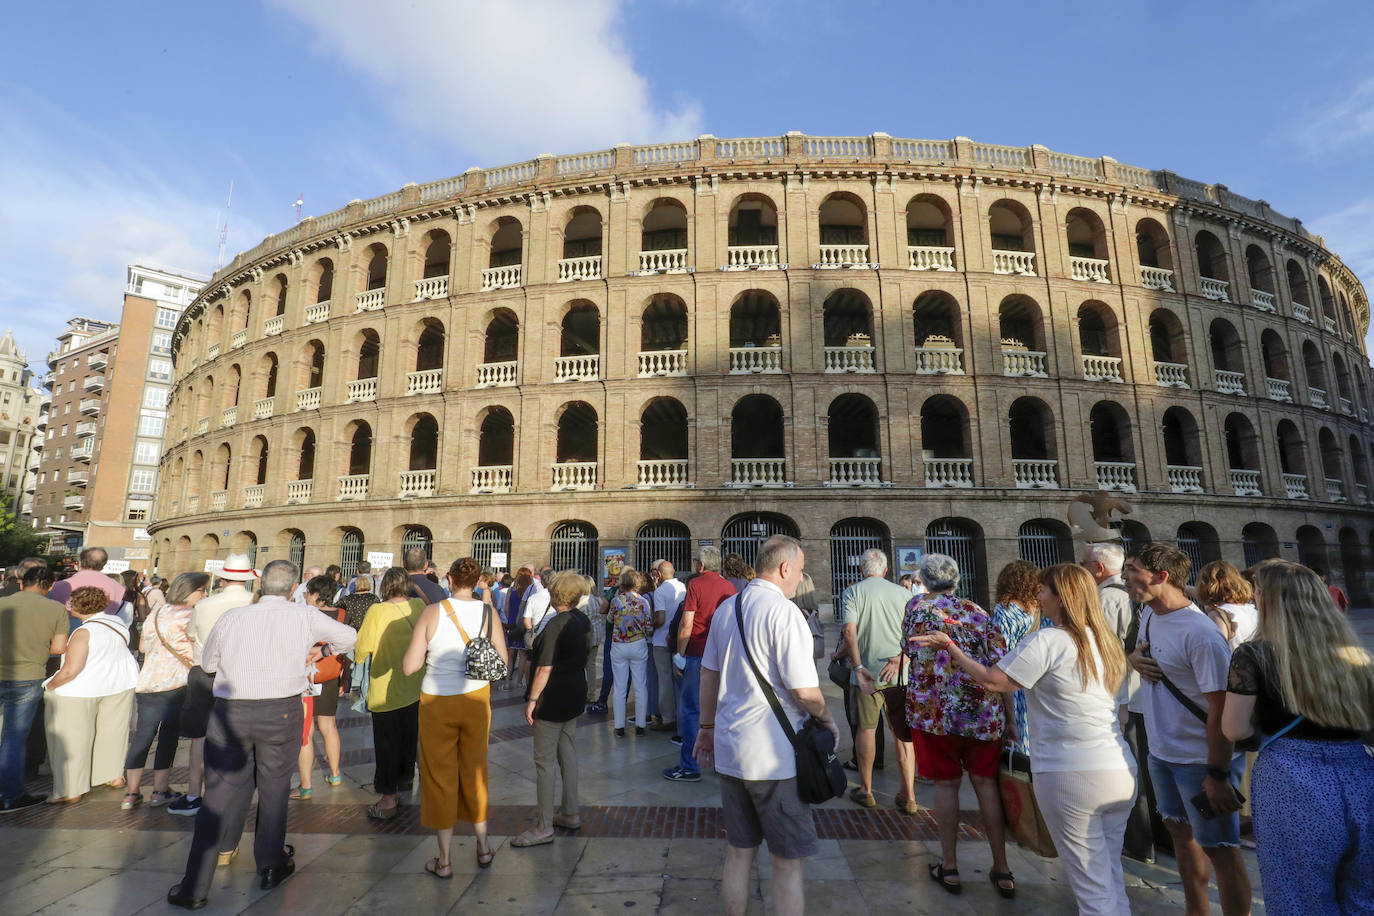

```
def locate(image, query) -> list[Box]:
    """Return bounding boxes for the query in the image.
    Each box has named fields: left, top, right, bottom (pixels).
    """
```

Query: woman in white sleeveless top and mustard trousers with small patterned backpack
left=403, top=556, right=510, bottom=880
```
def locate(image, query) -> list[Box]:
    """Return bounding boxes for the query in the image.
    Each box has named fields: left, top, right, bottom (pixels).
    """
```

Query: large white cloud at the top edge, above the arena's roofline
left=275, top=0, right=701, bottom=166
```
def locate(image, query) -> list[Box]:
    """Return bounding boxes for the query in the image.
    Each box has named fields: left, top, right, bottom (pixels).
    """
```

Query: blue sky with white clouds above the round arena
left=0, top=0, right=1374, bottom=364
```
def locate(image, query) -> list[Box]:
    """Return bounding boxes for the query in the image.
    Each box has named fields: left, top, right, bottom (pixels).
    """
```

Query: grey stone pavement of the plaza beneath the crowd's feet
left=0, top=612, right=1297, bottom=916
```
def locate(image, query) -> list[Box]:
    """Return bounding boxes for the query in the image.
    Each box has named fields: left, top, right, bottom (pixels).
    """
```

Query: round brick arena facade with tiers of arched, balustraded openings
left=150, top=133, right=1374, bottom=600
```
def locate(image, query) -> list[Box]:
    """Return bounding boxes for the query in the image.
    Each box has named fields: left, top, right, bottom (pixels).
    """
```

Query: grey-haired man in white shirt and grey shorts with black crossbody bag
left=694, top=534, right=840, bottom=916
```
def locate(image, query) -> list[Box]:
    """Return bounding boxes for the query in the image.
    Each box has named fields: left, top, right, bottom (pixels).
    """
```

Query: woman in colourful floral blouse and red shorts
left=901, top=553, right=1017, bottom=897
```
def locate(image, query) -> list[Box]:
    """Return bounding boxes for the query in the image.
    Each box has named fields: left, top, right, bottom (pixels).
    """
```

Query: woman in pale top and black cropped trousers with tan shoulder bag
left=120, top=573, right=210, bottom=812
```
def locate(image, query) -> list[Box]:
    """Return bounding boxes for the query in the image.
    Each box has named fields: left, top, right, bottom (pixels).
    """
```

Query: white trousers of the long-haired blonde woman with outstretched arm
left=1035, top=769, right=1135, bottom=916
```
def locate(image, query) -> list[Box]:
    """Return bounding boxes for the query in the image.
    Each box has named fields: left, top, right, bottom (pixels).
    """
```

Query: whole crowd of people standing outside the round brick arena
left=0, top=536, right=1374, bottom=916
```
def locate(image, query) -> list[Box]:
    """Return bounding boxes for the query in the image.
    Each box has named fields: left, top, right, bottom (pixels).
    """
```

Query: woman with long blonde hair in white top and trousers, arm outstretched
left=912, top=564, right=1135, bottom=916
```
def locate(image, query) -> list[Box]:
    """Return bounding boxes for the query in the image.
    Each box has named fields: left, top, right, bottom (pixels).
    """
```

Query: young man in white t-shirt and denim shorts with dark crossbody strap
left=1121, top=542, right=1250, bottom=916
